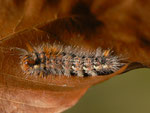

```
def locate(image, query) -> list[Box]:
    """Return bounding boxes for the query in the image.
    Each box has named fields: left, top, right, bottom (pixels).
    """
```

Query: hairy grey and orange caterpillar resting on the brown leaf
left=21, top=43, right=123, bottom=77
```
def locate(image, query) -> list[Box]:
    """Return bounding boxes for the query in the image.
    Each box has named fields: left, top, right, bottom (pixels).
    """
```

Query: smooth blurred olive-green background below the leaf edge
left=64, top=68, right=150, bottom=113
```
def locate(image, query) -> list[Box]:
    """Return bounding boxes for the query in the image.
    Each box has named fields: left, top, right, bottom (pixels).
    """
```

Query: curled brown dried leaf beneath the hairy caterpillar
left=0, top=0, right=150, bottom=113
